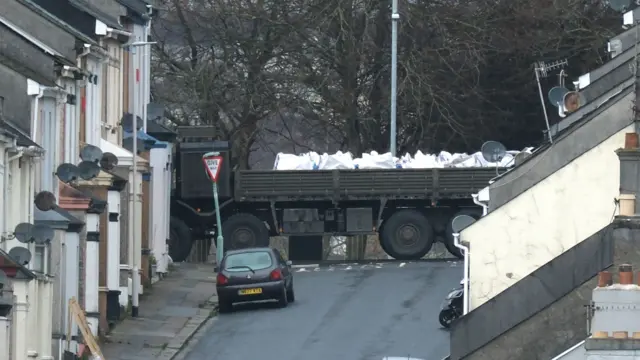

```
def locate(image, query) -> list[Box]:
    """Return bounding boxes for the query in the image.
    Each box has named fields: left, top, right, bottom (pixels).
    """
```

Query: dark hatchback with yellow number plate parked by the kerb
left=216, top=247, right=295, bottom=313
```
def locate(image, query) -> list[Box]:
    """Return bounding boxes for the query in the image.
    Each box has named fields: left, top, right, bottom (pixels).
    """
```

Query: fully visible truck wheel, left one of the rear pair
left=380, top=209, right=433, bottom=260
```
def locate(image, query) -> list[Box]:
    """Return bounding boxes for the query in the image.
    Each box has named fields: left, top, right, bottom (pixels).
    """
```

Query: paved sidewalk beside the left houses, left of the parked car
left=100, top=263, right=218, bottom=360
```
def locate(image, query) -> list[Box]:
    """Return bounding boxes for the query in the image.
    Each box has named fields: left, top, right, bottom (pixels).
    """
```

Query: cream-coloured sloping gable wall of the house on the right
left=461, top=109, right=633, bottom=310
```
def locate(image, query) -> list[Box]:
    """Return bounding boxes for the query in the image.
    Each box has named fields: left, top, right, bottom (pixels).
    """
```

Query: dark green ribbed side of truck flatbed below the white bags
left=234, top=168, right=497, bottom=202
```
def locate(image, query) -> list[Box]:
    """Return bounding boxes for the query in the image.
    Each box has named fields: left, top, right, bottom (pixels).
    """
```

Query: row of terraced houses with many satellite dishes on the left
left=0, top=0, right=160, bottom=360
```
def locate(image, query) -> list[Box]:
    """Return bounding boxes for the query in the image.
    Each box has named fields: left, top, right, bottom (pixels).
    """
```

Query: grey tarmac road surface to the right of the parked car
left=180, top=262, right=462, bottom=360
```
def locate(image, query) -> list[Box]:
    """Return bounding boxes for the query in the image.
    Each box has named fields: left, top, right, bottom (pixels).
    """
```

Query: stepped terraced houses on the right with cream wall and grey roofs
left=450, top=10, right=638, bottom=360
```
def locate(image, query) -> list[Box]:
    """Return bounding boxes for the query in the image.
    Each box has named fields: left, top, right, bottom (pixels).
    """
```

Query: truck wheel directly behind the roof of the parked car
left=222, top=213, right=269, bottom=251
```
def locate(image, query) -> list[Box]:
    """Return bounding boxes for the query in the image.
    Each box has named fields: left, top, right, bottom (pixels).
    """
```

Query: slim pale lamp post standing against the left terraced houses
left=125, top=41, right=156, bottom=317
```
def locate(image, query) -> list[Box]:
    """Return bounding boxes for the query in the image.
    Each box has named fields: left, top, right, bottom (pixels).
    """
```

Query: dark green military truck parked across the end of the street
left=170, top=127, right=496, bottom=261
